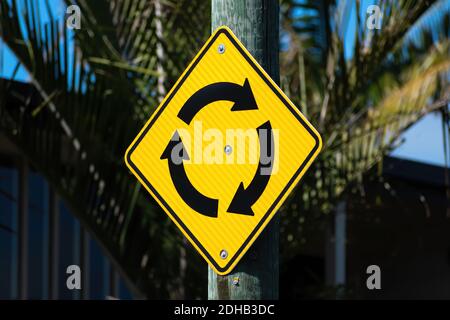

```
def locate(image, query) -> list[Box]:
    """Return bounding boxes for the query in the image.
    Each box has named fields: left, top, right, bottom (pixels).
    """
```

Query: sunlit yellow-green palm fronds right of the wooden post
left=281, top=0, right=450, bottom=264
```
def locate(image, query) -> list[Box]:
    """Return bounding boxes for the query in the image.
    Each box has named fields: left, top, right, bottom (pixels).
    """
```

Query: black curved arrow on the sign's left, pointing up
left=160, top=131, right=218, bottom=218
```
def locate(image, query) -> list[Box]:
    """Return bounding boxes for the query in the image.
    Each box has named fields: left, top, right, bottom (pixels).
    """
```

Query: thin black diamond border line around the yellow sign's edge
left=126, top=28, right=319, bottom=272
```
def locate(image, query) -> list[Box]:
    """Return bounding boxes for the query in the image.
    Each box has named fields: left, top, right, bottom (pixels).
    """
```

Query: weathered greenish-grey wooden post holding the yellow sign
left=208, top=0, right=280, bottom=299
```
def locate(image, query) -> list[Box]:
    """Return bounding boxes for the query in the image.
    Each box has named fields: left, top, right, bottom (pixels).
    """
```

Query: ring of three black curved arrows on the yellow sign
left=161, top=79, right=275, bottom=218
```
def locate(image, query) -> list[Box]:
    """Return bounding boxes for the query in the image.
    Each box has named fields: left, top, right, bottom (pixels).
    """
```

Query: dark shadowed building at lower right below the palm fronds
left=281, top=157, right=450, bottom=299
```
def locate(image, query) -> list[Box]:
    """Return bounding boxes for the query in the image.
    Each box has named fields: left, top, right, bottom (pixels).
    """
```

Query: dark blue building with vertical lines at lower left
left=0, top=94, right=133, bottom=299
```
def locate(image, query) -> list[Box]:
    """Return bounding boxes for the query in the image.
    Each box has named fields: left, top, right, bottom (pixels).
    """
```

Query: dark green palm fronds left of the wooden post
left=0, top=0, right=210, bottom=298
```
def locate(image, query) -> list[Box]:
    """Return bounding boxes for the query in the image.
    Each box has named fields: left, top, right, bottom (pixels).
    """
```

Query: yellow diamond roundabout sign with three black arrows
left=125, top=27, right=321, bottom=274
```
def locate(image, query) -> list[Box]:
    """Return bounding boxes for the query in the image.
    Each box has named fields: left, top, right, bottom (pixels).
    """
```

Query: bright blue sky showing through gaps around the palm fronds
left=0, top=0, right=445, bottom=166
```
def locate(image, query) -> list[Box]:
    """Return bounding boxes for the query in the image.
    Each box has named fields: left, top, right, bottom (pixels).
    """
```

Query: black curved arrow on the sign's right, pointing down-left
left=227, top=121, right=275, bottom=216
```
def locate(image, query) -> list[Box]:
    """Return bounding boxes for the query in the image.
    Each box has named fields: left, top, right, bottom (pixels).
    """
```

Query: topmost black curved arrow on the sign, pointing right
left=178, top=79, right=258, bottom=124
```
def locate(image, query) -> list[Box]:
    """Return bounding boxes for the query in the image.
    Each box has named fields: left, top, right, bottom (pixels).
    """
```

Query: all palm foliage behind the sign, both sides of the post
left=0, top=0, right=450, bottom=298
